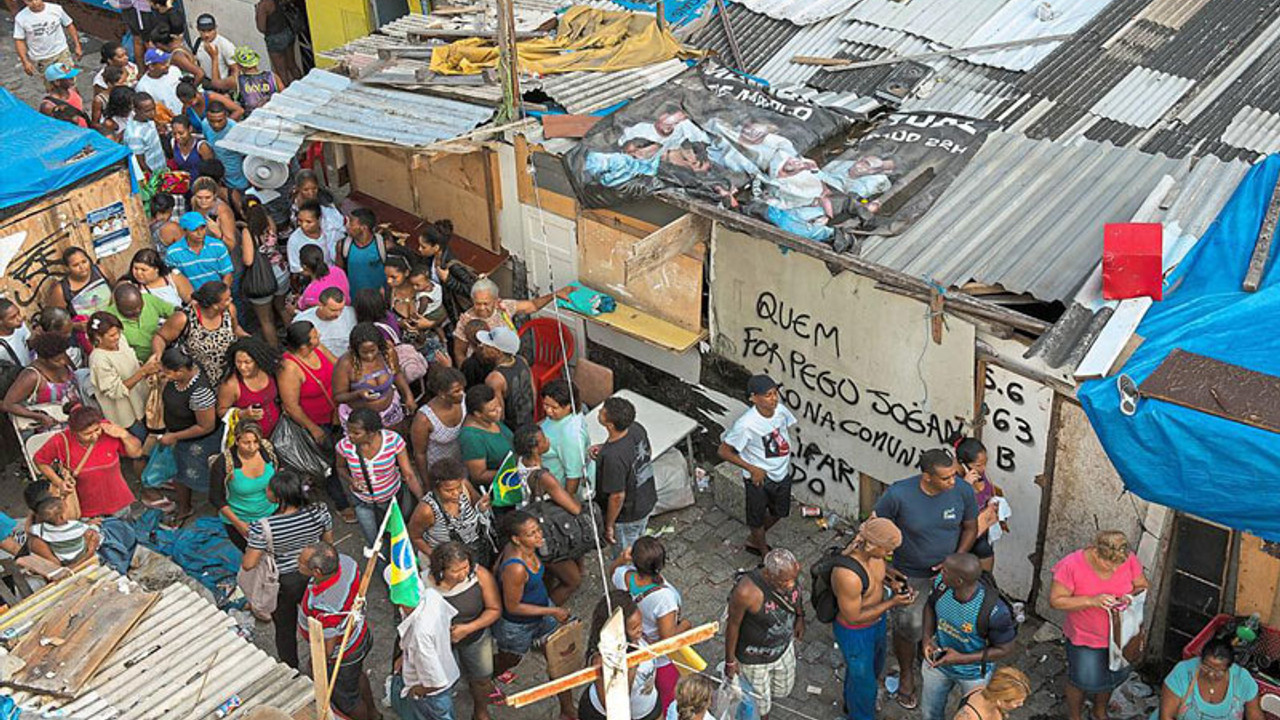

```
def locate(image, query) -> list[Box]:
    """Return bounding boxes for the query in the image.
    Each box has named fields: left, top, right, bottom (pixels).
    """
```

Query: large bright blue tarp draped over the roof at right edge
left=1078, top=155, right=1280, bottom=541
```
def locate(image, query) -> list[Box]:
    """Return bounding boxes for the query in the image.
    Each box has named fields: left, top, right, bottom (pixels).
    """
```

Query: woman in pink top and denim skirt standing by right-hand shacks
left=1048, top=530, right=1148, bottom=720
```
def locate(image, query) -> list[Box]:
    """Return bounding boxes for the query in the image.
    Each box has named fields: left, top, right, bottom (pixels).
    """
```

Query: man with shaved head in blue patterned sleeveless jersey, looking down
left=920, top=552, right=1018, bottom=720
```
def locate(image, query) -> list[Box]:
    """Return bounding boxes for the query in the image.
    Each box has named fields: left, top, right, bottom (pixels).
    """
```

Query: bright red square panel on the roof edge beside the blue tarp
left=1102, top=223, right=1165, bottom=300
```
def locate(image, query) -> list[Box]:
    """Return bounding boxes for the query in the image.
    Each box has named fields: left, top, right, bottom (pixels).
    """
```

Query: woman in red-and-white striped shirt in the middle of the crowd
left=337, top=407, right=422, bottom=544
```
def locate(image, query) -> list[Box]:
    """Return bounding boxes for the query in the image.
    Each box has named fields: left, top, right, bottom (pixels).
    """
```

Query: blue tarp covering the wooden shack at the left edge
left=0, top=87, right=129, bottom=209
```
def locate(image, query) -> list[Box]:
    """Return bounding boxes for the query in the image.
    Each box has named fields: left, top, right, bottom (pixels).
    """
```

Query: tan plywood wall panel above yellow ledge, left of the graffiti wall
left=577, top=210, right=707, bottom=333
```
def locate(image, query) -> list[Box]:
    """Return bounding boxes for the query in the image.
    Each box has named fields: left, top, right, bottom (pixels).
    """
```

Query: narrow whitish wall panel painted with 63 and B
left=979, top=363, right=1053, bottom=600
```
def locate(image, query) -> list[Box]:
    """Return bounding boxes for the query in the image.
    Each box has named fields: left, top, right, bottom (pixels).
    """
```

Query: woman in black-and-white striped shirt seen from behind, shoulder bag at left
left=241, top=470, right=333, bottom=669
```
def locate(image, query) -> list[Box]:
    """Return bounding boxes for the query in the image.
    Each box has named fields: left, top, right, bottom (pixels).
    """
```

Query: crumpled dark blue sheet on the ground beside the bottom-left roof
left=133, top=510, right=243, bottom=609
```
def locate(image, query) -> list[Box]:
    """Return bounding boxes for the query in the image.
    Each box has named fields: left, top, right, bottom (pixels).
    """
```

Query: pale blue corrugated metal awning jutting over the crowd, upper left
left=219, top=69, right=493, bottom=161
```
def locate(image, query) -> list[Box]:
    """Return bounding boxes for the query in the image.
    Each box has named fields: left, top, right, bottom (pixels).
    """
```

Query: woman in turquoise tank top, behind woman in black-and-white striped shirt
left=209, top=421, right=280, bottom=552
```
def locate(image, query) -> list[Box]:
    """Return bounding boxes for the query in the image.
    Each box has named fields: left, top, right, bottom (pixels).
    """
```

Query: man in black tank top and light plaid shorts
left=724, top=550, right=804, bottom=720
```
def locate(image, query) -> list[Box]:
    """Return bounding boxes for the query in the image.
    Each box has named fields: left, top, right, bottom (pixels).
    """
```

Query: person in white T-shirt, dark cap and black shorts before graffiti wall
left=719, top=375, right=796, bottom=557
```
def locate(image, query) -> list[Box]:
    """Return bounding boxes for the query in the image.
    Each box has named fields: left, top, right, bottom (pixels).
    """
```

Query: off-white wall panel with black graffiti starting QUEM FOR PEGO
left=710, top=227, right=974, bottom=515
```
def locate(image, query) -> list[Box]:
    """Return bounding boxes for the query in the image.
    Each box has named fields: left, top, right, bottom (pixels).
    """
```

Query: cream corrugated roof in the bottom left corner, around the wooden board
left=0, top=566, right=312, bottom=720
